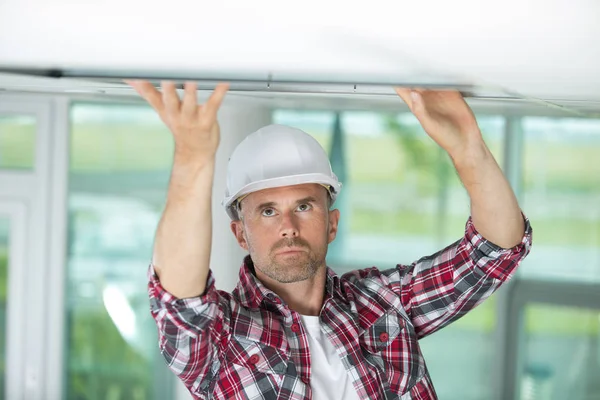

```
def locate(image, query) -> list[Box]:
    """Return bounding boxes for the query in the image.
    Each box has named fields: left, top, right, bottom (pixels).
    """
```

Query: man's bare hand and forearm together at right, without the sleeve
left=396, top=88, right=525, bottom=248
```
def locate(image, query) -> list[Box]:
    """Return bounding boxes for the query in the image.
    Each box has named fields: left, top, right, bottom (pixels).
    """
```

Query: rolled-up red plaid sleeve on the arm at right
left=385, top=215, right=532, bottom=338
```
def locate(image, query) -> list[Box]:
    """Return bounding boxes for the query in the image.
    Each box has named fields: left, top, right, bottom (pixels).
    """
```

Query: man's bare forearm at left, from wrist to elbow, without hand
left=153, top=156, right=214, bottom=298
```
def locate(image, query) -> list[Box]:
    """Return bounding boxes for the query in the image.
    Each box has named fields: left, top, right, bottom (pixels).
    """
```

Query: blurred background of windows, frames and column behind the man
left=0, top=94, right=600, bottom=400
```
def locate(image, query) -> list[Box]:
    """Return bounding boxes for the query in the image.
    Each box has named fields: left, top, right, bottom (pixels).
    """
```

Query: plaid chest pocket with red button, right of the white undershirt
left=361, top=310, right=426, bottom=395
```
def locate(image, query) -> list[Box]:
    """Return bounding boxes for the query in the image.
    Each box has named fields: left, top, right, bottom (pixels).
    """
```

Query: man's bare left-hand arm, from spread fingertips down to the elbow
left=127, top=81, right=228, bottom=298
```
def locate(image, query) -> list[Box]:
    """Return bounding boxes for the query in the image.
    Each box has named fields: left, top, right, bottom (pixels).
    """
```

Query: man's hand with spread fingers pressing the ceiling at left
left=126, top=81, right=229, bottom=162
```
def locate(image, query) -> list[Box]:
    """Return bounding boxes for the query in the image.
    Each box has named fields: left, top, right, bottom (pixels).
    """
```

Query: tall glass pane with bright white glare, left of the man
left=66, top=103, right=174, bottom=400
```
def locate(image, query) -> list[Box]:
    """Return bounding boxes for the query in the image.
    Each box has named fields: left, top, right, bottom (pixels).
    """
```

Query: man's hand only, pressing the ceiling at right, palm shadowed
left=395, top=88, right=483, bottom=160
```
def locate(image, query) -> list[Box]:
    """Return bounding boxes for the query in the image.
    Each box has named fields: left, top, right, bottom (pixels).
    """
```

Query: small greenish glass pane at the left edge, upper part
left=0, top=115, right=36, bottom=169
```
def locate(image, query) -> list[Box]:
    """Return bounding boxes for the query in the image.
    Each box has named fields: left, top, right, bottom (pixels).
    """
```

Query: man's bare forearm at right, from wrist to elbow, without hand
left=450, top=141, right=525, bottom=248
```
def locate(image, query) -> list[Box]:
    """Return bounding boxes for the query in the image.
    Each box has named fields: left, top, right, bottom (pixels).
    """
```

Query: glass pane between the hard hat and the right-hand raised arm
left=342, top=113, right=504, bottom=267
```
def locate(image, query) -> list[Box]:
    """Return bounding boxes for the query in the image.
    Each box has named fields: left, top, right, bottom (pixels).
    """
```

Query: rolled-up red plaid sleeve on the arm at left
left=148, top=265, right=231, bottom=392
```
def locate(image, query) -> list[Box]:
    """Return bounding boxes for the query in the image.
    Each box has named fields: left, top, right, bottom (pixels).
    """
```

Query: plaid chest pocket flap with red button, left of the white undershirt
left=226, top=335, right=288, bottom=375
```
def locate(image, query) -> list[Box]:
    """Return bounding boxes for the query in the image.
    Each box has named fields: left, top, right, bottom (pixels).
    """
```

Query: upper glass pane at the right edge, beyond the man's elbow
left=521, top=117, right=600, bottom=283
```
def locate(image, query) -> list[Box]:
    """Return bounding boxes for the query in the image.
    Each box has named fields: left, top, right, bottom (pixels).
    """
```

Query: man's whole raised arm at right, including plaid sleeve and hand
left=383, top=89, right=532, bottom=338
